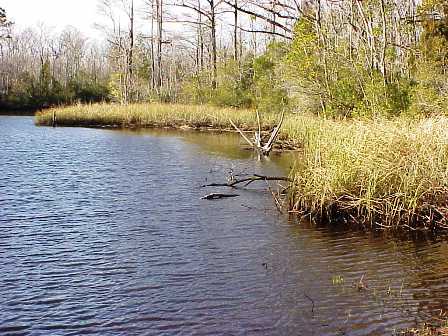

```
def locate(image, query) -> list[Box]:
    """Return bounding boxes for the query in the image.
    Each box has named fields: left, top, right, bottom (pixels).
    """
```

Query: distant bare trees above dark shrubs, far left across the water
left=0, top=26, right=109, bottom=109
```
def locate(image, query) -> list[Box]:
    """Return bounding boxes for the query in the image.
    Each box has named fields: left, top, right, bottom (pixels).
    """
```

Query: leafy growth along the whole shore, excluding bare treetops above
left=4, top=0, right=448, bottom=118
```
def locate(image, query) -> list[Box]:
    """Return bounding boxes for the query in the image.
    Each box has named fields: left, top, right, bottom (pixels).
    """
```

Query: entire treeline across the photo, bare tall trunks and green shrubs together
left=0, top=0, right=448, bottom=117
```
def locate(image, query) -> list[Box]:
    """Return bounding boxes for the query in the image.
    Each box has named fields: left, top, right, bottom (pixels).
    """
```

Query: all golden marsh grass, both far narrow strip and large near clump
left=36, top=104, right=448, bottom=230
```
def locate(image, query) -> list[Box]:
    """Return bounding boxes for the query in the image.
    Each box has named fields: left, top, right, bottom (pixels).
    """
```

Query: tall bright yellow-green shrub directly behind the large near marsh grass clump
left=287, top=16, right=413, bottom=118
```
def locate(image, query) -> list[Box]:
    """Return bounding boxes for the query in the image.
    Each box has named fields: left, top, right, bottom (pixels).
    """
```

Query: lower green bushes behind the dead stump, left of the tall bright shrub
left=182, top=43, right=289, bottom=112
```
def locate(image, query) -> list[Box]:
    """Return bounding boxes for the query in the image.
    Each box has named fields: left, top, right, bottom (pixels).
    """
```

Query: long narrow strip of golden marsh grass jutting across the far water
left=36, top=104, right=282, bottom=130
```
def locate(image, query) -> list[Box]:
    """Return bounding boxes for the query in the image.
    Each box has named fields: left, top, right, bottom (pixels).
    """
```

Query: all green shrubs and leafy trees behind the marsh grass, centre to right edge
left=176, top=0, right=448, bottom=118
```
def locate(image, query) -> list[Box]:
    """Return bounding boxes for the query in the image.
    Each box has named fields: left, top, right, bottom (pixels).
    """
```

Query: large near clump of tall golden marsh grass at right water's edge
left=290, top=117, right=448, bottom=230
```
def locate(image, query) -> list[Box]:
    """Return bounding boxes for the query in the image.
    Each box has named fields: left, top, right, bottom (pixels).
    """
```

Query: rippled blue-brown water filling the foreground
left=0, top=116, right=448, bottom=335
